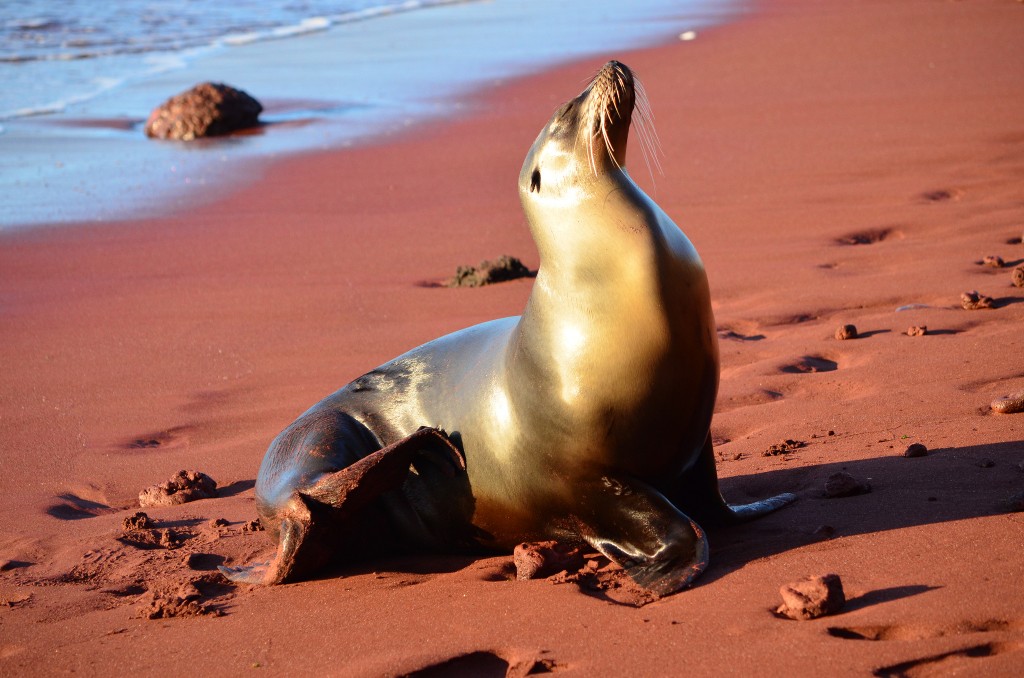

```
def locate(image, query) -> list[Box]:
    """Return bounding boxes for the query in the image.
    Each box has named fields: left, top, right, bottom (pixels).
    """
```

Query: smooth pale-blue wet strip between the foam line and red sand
left=0, top=0, right=741, bottom=229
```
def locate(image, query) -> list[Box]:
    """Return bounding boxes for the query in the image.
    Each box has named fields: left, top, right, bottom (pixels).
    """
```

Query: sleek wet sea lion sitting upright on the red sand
left=221, top=61, right=795, bottom=595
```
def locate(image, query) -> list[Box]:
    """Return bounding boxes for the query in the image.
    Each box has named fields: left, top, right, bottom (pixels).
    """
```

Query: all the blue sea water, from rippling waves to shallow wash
left=0, top=0, right=740, bottom=228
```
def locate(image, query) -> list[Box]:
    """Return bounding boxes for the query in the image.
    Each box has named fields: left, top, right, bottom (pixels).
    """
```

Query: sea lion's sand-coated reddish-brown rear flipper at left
left=224, top=428, right=466, bottom=584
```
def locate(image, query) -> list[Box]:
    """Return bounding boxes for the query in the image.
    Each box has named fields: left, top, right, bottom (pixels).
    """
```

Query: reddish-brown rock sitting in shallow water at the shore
left=145, top=82, right=263, bottom=140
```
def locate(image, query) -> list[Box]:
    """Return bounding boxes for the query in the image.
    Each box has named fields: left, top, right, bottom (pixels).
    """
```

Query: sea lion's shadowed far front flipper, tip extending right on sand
left=666, top=435, right=797, bottom=526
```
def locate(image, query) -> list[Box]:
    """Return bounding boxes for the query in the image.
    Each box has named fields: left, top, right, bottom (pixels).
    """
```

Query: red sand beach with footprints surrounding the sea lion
left=0, top=0, right=1024, bottom=676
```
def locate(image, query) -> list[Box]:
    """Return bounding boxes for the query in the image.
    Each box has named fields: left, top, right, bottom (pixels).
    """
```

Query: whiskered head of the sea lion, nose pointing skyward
left=519, top=61, right=653, bottom=202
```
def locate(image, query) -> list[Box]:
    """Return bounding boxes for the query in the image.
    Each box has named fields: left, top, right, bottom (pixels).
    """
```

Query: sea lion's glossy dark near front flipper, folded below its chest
left=571, top=476, right=708, bottom=596
